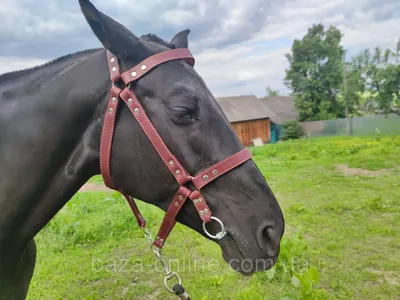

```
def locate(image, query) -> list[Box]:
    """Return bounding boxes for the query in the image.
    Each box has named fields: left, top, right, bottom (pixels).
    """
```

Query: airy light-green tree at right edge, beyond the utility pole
left=346, top=39, right=400, bottom=116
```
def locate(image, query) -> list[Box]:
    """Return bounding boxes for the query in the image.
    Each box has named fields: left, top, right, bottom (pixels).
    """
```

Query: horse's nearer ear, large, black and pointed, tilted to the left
left=79, top=0, right=148, bottom=58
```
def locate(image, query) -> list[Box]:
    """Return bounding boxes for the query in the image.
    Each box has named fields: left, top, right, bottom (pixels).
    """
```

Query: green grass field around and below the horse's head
left=28, top=136, right=400, bottom=300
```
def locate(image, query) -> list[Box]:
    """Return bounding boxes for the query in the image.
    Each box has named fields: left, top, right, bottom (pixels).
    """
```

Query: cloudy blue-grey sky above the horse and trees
left=0, top=0, right=400, bottom=97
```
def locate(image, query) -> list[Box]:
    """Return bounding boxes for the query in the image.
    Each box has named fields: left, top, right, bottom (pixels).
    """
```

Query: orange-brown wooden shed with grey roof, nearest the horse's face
left=216, top=95, right=273, bottom=146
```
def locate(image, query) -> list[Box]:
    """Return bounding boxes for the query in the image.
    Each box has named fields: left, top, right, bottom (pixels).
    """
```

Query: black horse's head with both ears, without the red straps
left=79, top=0, right=284, bottom=274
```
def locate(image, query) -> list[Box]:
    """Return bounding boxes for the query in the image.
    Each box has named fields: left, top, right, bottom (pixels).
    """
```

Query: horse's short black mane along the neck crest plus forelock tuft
left=0, top=33, right=175, bottom=82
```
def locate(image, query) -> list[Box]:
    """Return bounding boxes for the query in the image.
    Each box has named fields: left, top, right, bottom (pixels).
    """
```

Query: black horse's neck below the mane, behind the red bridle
left=0, top=51, right=110, bottom=245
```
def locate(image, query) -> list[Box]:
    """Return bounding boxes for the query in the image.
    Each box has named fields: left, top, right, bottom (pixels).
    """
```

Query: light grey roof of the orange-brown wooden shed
left=217, top=95, right=274, bottom=122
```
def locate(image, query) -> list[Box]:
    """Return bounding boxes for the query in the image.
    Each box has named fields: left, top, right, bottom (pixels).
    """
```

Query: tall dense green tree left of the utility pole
left=285, top=24, right=344, bottom=121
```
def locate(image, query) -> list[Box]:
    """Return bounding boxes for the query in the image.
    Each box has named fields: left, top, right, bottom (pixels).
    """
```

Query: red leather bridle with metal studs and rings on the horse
left=100, top=48, right=252, bottom=299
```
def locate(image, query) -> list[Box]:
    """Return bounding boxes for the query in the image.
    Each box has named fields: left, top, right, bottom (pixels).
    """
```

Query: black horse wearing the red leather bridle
left=0, top=0, right=285, bottom=300
